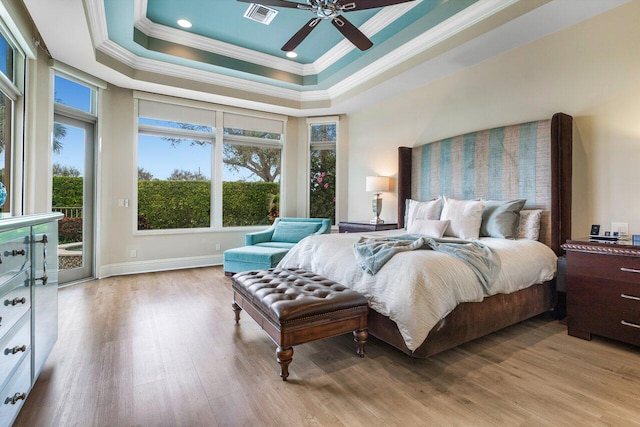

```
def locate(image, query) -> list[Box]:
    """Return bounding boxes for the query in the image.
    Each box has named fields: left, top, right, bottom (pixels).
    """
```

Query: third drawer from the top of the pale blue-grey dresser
left=0, top=310, right=31, bottom=389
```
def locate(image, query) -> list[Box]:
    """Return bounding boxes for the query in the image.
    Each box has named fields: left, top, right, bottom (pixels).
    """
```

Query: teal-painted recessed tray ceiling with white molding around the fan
left=104, top=0, right=478, bottom=91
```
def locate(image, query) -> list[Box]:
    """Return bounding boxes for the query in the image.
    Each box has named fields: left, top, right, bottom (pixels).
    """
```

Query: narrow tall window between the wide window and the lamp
left=309, top=119, right=338, bottom=225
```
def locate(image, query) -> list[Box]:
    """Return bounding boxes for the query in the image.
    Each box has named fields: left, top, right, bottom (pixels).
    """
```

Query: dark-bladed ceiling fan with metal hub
left=238, top=0, right=414, bottom=52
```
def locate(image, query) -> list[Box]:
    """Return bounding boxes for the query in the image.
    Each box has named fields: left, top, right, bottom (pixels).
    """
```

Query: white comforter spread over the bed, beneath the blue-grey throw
left=278, top=230, right=556, bottom=351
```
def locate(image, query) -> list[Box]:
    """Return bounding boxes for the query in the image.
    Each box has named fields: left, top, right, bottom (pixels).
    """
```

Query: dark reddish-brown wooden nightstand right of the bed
left=563, top=240, right=640, bottom=345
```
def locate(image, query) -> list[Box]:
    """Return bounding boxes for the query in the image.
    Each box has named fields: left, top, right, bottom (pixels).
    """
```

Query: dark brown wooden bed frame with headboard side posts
left=368, top=113, right=573, bottom=358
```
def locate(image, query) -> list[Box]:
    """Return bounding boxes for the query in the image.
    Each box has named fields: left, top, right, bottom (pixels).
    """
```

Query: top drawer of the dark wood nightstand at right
left=567, top=252, right=640, bottom=284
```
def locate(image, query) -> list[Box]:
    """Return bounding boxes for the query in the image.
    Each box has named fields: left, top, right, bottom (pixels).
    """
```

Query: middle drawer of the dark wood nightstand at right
left=567, top=275, right=640, bottom=312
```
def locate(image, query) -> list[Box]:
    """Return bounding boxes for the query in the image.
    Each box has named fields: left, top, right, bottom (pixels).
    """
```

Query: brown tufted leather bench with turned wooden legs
left=232, top=269, right=369, bottom=381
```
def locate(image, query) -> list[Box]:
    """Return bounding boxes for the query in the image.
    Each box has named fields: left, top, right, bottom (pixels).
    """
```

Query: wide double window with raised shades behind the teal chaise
left=137, top=98, right=284, bottom=231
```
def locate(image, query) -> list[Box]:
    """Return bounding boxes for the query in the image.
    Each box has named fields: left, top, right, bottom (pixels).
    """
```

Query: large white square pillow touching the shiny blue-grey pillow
left=440, top=197, right=487, bottom=239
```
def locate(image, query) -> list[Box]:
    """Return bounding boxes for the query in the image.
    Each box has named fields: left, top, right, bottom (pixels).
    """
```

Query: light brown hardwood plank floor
left=15, top=267, right=640, bottom=427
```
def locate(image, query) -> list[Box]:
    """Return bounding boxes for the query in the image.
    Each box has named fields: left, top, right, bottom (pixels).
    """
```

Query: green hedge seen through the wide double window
left=138, top=181, right=280, bottom=230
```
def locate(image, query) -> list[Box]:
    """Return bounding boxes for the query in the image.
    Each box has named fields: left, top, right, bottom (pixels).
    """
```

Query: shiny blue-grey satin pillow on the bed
left=480, top=199, right=527, bottom=239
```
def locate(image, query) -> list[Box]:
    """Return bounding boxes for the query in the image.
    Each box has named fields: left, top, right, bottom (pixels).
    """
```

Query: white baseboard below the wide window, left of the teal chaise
left=97, top=254, right=222, bottom=279
